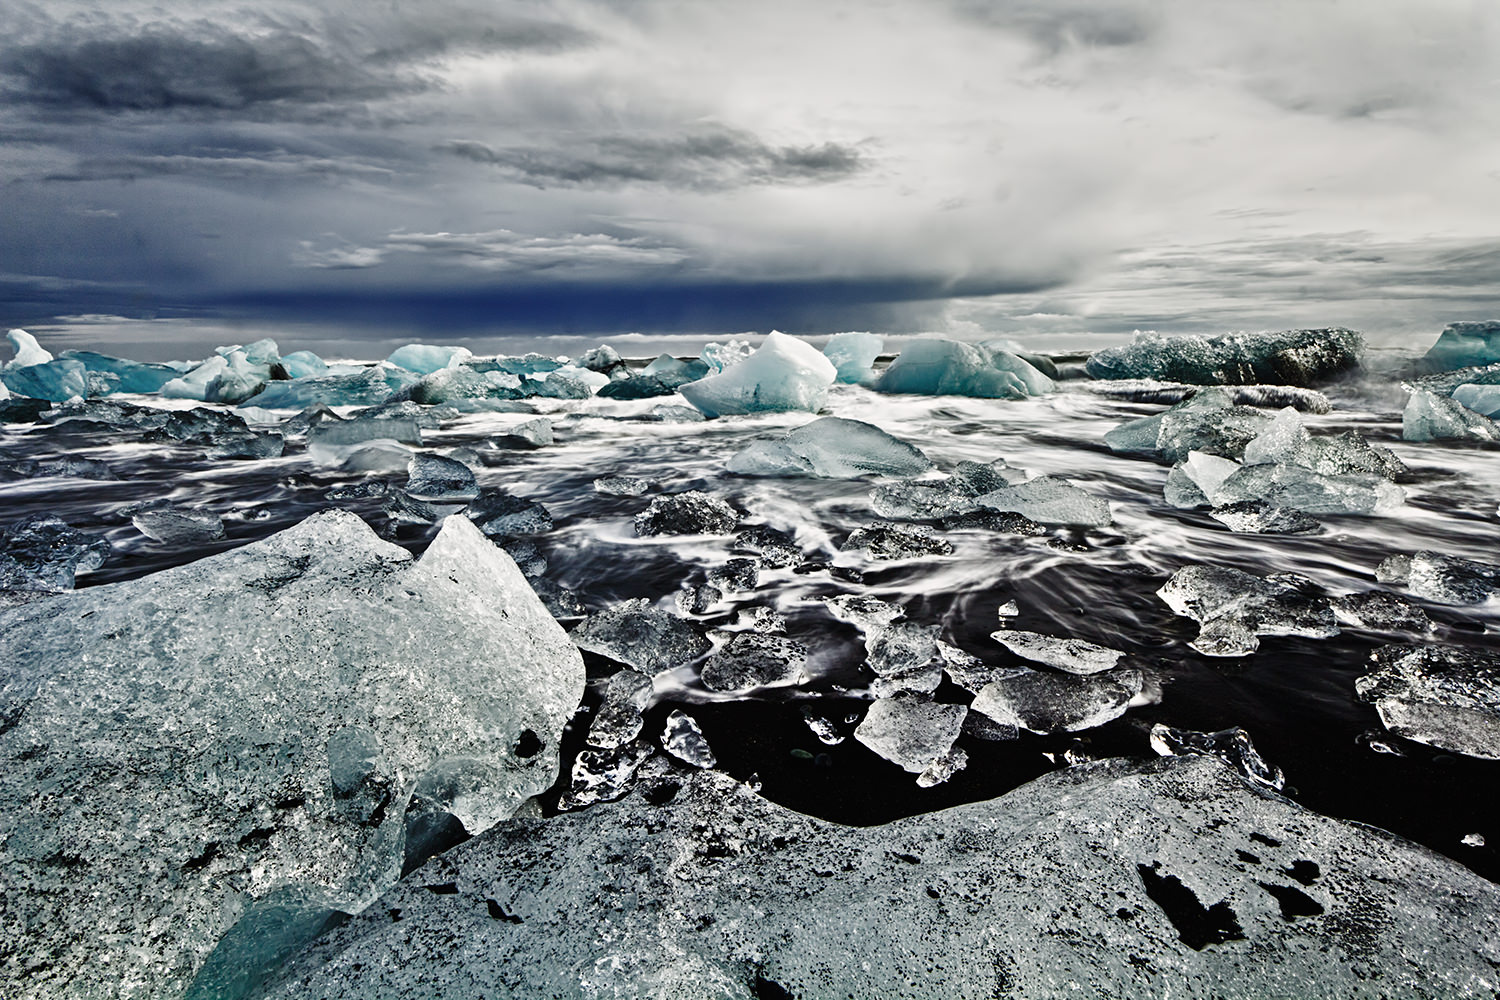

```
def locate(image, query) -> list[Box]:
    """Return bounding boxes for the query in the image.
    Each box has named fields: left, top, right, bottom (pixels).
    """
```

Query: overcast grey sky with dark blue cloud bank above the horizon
left=0, top=0, right=1500, bottom=355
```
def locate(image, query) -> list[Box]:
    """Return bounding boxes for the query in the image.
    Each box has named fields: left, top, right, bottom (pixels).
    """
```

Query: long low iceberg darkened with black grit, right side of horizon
left=1085, top=328, right=1365, bottom=387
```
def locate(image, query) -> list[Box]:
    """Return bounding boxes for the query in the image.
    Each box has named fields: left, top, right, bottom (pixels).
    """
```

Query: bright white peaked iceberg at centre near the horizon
left=678, top=331, right=837, bottom=417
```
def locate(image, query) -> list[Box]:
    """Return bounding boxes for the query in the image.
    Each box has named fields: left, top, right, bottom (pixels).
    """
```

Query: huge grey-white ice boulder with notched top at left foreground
left=0, top=511, right=584, bottom=999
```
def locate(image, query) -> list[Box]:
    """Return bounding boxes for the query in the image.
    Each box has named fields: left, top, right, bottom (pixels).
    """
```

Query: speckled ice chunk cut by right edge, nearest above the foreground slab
left=1355, top=645, right=1500, bottom=760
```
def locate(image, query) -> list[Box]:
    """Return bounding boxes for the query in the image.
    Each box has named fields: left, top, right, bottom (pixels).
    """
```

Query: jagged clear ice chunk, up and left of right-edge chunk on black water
left=1157, top=565, right=1338, bottom=657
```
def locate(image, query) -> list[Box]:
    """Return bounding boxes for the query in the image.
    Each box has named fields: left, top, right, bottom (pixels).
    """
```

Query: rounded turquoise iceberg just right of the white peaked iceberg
left=875, top=339, right=1055, bottom=399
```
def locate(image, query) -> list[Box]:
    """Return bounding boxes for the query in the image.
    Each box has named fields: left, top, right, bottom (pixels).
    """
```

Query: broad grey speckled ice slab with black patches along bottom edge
left=252, top=756, right=1500, bottom=1000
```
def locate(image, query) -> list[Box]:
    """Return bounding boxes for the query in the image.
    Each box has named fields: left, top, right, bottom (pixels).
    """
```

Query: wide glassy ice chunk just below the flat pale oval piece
left=971, top=669, right=1143, bottom=733
